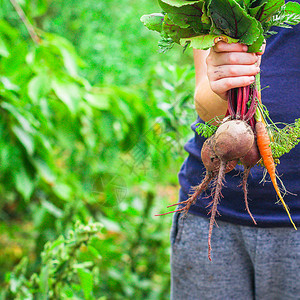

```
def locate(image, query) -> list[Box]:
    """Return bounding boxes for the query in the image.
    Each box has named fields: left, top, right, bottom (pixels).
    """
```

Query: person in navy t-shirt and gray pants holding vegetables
left=171, top=17, right=300, bottom=300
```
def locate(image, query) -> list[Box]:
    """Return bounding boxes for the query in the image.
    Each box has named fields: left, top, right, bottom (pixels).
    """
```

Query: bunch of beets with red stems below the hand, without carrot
left=160, top=85, right=265, bottom=260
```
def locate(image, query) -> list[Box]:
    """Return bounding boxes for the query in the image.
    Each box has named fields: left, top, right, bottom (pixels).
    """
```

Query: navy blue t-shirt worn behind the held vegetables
left=179, top=14, right=300, bottom=227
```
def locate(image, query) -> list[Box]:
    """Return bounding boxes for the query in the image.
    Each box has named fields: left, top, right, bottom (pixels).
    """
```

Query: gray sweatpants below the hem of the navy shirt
left=171, top=214, right=300, bottom=300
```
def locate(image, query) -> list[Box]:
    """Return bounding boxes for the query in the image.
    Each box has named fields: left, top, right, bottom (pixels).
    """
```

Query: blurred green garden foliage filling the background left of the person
left=0, top=0, right=196, bottom=299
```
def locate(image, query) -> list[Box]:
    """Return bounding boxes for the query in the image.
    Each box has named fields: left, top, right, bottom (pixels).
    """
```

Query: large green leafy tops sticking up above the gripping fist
left=141, top=0, right=300, bottom=52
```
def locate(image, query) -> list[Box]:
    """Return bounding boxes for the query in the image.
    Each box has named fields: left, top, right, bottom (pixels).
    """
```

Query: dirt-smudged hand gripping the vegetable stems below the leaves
left=206, top=41, right=265, bottom=100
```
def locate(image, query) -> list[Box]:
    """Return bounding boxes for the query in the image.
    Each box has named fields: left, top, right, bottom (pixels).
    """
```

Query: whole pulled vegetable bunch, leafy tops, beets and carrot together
left=141, top=0, right=300, bottom=260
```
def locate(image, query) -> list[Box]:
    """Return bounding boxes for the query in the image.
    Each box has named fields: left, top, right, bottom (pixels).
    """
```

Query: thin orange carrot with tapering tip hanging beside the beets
left=255, top=121, right=297, bottom=230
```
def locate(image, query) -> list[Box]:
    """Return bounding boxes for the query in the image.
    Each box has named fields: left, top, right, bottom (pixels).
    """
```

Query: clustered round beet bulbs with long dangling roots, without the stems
left=158, top=120, right=259, bottom=260
